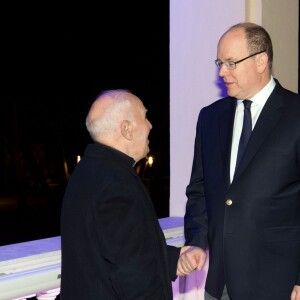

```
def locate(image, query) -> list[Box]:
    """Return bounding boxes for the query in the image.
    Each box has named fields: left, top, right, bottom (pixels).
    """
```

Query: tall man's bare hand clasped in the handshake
left=176, top=246, right=206, bottom=276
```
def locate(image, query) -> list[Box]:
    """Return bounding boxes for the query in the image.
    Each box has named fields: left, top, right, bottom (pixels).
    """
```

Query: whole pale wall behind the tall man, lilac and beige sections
left=170, top=0, right=299, bottom=300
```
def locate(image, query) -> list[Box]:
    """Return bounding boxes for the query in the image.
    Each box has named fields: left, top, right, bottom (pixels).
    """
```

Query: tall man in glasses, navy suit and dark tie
left=179, top=23, right=300, bottom=300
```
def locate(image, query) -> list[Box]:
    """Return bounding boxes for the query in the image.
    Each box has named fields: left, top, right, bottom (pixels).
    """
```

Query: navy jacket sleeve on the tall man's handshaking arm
left=184, top=110, right=208, bottom=249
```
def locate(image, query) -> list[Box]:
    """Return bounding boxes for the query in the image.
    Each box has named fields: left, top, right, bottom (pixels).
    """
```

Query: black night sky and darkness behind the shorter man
left=0, top=1, right=169, bottom=245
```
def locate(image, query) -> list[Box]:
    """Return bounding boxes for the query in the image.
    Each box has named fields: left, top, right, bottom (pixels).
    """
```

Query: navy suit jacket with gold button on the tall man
left=185, top=81, right=300, bottom=300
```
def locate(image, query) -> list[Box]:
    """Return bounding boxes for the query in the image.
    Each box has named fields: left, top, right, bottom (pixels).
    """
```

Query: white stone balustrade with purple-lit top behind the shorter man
left=0, top=217, right=184, bottom=300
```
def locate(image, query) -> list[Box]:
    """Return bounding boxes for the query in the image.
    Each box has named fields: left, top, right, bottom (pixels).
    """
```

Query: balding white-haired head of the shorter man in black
left=86, top=90, right=152, bottom=161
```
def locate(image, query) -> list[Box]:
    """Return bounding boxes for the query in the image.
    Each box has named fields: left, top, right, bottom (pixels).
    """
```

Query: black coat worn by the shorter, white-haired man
left=61, top=143, right=180, bottom=300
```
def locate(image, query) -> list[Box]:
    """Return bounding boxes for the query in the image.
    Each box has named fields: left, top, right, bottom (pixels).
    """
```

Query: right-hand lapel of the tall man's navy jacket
left=234, top=83, right=284, bottom=179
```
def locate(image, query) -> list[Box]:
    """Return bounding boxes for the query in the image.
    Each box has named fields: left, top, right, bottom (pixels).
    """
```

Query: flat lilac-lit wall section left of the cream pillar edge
left=170, top=0, right=245, bottom=216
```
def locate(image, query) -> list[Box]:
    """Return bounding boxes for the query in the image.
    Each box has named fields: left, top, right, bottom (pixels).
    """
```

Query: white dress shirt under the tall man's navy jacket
left=230, top=76, right=276, bottom=182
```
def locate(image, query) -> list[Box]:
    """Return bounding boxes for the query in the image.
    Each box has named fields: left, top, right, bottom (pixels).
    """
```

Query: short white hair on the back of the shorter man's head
left=86, top=89, right=133, bottom=141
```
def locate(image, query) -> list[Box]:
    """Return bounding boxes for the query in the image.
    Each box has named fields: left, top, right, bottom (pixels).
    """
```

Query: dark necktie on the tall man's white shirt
left=235, top=100, right=252, bottom=169
